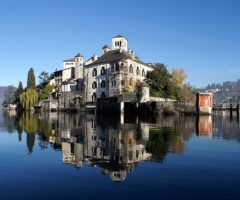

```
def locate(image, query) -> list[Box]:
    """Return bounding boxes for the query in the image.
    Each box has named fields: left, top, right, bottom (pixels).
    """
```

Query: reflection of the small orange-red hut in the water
left=197, top=115, right=213, bottom=137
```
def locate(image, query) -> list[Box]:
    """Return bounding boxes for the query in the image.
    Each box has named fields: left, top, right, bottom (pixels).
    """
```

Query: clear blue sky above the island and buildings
left=0, top=0, right=240, bottom=87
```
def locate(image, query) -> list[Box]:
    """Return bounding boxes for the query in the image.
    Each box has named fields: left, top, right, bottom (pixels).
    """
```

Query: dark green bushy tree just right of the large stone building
left=145, top=63, right=173, bottom=98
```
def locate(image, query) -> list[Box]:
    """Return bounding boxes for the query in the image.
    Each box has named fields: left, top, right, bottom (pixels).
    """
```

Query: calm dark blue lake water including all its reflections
left=0, top=112, right=240, bottom=200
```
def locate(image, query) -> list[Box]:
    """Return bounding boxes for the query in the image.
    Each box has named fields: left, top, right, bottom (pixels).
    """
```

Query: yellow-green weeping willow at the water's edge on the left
left=20, top=89, right=38, bottom=110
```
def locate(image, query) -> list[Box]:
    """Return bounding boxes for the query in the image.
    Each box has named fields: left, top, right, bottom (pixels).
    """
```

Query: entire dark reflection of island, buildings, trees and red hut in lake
left=3, top=112, right=240, bottom=182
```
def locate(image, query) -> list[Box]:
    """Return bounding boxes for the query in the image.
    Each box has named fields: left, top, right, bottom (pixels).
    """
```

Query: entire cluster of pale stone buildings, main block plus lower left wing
left=52, top=35, right=153, bottom=102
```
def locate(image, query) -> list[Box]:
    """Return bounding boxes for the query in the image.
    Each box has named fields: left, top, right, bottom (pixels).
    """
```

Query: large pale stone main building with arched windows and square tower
left=84, top=35, right=153, bottom=102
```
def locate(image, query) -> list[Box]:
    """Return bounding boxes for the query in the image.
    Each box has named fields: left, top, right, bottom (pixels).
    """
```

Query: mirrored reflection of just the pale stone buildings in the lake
left=57, top=115, right=151, bottom=181
